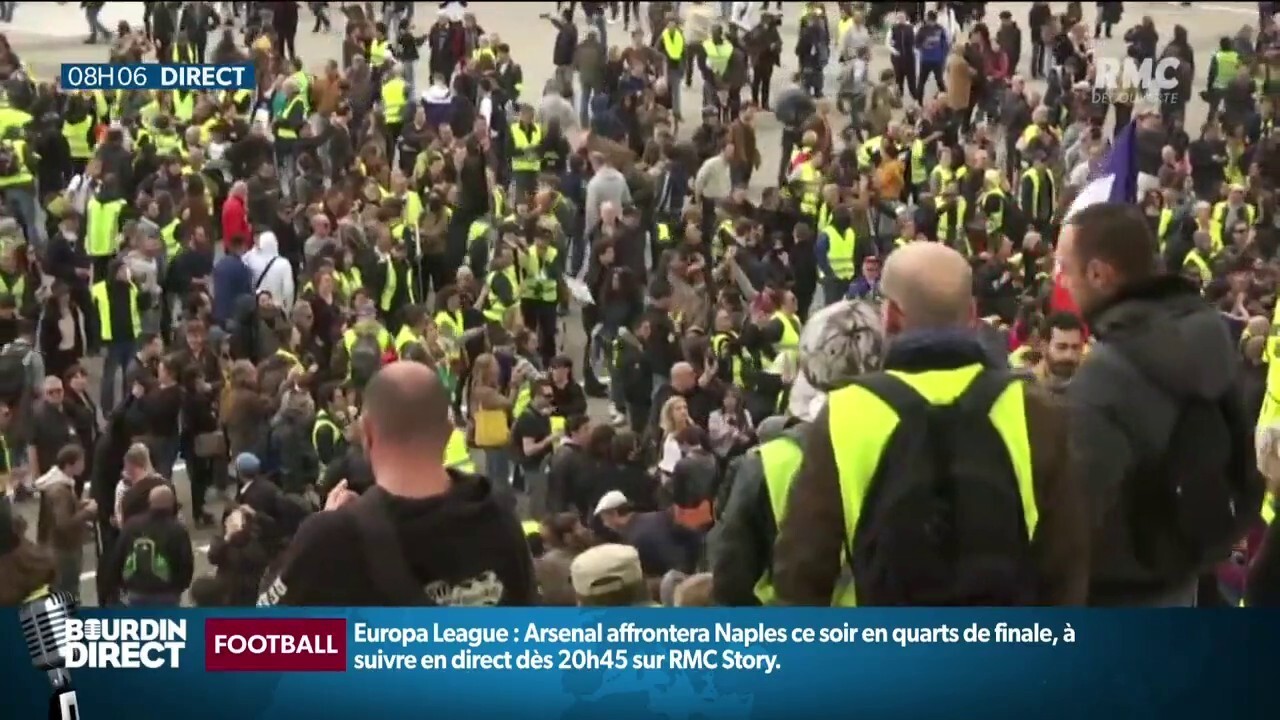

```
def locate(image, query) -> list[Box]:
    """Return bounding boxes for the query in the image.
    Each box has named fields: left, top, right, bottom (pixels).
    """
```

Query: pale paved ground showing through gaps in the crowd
left=0, top=3, right=1257, bottom=605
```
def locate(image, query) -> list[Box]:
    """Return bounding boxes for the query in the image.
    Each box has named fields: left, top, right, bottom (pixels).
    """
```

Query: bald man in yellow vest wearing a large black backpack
left=773, top=242, right=1089, bottom=605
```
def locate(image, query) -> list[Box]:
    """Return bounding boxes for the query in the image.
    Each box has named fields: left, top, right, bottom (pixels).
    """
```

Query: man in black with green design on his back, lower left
left=97, top=484, right=196, bottom=607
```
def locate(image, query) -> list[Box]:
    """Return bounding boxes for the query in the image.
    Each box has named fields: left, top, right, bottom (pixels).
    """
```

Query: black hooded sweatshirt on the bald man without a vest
left=259, top=470, right=538, bottom=606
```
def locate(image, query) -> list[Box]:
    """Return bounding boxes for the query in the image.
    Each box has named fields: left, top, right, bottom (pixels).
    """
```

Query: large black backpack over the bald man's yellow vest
left=846, top=370, right=1037, bottom=606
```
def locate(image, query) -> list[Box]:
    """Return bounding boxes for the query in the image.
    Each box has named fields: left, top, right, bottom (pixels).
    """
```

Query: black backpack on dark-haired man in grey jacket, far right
left=1125, top=384, right=1266, bottom=577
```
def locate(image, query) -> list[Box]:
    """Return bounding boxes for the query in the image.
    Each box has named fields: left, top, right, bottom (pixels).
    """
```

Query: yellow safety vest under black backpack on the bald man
left=827, top=364, right=1039, bottom=607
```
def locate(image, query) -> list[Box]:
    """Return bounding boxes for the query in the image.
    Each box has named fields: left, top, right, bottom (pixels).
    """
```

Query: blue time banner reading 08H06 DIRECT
left=59, top=63, right=255, bottom=91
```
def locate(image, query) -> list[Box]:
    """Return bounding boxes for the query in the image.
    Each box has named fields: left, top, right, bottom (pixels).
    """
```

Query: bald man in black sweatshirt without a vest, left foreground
left=259, top=361, right=538, bottom=606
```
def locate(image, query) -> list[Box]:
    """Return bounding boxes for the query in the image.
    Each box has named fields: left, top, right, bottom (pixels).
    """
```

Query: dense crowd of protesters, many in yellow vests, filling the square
left=0, top=3, right=1280, bottom=605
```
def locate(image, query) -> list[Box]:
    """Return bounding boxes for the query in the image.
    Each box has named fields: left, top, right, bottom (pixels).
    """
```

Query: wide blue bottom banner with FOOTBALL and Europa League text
left=0, top=609, right=1280, bottom=720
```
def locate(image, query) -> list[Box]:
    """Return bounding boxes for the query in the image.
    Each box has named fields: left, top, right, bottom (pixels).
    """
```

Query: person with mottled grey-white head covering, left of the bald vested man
left=708, top=300, right=884, bottom=607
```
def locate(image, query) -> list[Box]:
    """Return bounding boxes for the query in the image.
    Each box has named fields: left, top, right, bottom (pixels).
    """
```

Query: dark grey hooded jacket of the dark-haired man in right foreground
left=1066, top=277, right=1240, bottom=606
